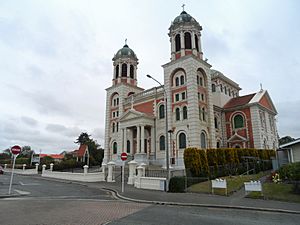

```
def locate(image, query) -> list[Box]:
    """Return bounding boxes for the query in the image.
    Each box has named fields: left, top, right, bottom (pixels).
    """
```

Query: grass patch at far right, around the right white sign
left=247, top=183, right=300, bottom=203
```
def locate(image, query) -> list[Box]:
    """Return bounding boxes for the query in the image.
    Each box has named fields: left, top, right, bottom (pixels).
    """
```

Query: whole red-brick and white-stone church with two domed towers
left=104, top=11, right=278, bottom=167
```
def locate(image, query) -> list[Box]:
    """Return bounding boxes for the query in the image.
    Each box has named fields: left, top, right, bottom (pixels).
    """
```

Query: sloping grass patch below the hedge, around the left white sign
left=188, top=172, right=266, bottom=195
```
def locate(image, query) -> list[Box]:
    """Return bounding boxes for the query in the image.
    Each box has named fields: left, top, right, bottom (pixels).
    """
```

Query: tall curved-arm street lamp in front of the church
left=146, top=74, right=170, bottom=191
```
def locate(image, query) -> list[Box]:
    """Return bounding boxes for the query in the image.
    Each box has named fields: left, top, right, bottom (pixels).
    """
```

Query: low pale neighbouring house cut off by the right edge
left=277, top=138, right=300, bottom=166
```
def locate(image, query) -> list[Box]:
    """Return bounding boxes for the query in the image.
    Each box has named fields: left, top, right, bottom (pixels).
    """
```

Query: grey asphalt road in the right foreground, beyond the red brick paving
left=109, top=206, right=300, bottom=225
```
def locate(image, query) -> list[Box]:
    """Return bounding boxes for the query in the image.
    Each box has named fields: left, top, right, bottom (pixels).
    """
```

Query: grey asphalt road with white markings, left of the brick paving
left=0, top=174, right=114, bottom=200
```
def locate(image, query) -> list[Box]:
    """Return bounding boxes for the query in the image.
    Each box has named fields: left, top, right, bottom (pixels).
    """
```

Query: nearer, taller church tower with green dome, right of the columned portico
left=163, top=5, right=215, bottom=160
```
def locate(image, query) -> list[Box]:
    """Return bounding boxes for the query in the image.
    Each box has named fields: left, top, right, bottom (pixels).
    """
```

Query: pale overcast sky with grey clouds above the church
left=0, top=0, right=300, bottom=153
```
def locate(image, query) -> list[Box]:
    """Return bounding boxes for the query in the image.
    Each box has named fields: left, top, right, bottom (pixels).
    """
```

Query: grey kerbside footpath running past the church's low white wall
left=0, top=175, right=300, bottom=214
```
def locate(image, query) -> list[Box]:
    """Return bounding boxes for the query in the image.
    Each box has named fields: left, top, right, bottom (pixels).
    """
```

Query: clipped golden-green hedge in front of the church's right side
left=184, top=148, right=275, bottom=177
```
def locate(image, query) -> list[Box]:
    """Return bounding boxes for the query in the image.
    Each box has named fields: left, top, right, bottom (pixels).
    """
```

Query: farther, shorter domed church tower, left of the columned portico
left=104, top=41, right=143, bottom=163
